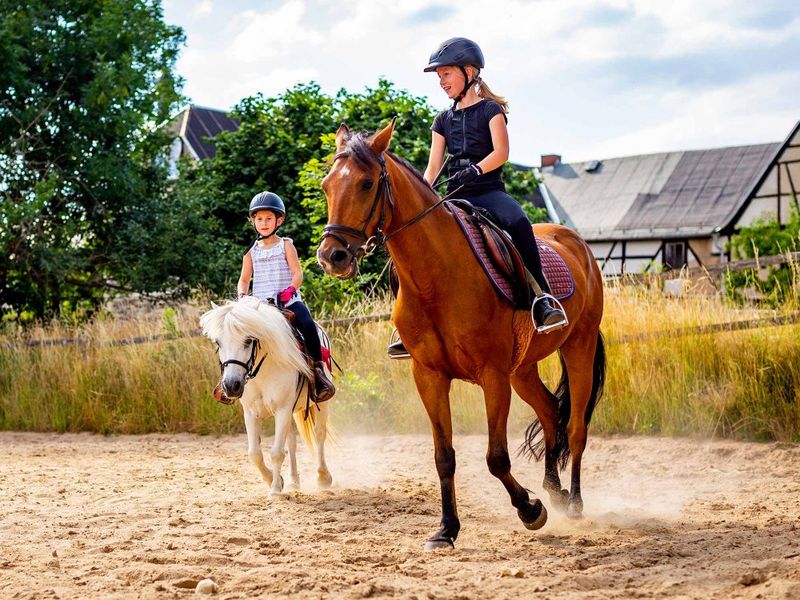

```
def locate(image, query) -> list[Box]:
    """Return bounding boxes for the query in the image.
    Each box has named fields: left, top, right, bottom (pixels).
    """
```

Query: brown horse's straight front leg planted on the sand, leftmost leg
left=411, top=361, right=461, bottom=550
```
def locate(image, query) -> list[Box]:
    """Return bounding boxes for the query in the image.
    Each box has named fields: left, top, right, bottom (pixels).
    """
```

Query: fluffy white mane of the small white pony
left=200, top=297, right=310, bottom=376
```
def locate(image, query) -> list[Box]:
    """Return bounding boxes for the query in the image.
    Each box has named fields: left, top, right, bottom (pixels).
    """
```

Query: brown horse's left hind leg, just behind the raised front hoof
left=511, top=363, right=569, bottom=510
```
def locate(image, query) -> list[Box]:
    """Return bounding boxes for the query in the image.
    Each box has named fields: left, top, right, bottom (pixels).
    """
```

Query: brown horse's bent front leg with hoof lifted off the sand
left=481, top=373, right=547, bottom=529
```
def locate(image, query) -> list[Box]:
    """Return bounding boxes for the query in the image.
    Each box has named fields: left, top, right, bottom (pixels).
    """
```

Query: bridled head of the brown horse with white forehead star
left=317, top=119, right=395, bottom=279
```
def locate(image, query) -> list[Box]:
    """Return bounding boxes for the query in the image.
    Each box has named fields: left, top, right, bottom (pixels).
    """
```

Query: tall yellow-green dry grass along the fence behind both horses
left=0, top=284, right=800, bottom=441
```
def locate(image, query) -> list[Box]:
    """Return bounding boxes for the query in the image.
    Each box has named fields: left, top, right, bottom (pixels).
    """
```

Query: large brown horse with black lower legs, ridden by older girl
left=317, top=121, right=605, bottom=549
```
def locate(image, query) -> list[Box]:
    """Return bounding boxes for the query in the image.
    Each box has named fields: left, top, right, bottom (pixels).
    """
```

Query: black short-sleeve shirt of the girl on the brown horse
left=431, top=99, right=508, bottom=194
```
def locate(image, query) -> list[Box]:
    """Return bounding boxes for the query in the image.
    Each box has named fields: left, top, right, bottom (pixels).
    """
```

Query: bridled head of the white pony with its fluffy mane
left=200, top=297, right=310, bottom=398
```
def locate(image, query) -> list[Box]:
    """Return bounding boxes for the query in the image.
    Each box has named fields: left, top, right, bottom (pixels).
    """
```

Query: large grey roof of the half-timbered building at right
left=542, top=143, right=782, bottom=241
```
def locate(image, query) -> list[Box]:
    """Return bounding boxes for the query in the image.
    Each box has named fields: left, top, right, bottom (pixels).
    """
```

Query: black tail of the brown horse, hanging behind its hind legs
left=521, top=331, right=606, bottom=470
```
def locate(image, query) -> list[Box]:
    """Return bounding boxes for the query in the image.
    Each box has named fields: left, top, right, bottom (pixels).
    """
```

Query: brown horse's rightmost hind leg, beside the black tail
left=561, top=332, right=597, bottom=519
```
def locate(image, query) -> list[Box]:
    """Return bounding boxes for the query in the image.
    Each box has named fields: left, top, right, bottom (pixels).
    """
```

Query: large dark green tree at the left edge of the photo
left=0, top=0, right=184, bottom=316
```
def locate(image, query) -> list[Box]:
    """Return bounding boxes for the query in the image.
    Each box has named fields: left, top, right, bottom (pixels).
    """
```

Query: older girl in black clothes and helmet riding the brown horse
left=388, top=38, right=567, bottom=358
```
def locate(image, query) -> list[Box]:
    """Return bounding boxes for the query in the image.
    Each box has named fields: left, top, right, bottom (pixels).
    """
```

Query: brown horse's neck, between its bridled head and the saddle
left=387, top=165, right=463, bottom=295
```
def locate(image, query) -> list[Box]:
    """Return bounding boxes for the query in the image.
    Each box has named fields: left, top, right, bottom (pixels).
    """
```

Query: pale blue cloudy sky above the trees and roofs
left=164, top=0, right=800, bottom=165
